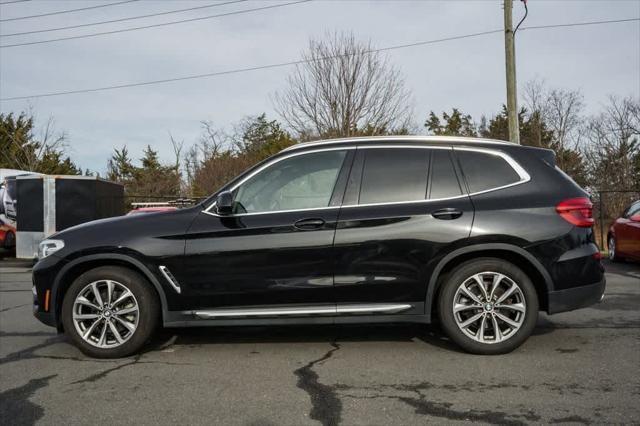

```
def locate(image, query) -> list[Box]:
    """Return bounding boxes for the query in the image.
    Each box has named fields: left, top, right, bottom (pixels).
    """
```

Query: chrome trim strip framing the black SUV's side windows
left=203, top=144, right=531, bottom=217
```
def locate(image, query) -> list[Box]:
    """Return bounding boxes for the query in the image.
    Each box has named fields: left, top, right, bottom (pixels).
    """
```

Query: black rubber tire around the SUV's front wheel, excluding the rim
left=62, top=266, right=160, bottom=358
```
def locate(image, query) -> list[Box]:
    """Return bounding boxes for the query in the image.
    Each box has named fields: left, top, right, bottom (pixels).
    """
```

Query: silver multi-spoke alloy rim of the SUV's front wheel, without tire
left=72, top=280, right=140, bottom=349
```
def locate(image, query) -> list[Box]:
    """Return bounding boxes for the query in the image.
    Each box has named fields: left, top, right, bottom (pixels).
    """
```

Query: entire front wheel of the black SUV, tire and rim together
left=62, top=266, right=160, bottom=358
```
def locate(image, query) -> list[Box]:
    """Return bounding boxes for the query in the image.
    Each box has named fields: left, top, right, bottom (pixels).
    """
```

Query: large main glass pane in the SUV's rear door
left=359, top=148, right=429, bottom=204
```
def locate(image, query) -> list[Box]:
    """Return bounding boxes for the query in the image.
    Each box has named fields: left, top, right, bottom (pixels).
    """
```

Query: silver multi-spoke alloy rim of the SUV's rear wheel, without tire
left=453, top=271, right=527, bottom=344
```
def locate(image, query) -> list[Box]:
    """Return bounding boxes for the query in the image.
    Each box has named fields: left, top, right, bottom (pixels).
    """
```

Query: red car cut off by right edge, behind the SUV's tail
left=607, top=200, right=640, bottom=261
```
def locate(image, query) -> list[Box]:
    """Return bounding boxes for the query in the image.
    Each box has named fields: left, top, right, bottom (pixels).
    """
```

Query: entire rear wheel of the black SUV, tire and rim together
left=438, top=258, right=538, bottom=355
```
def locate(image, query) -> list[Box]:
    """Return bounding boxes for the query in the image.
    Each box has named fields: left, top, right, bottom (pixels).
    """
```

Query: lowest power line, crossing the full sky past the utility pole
left=0, top=18, right=640, bottom=101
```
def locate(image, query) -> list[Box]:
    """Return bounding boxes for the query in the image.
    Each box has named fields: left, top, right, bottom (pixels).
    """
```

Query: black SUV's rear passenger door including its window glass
left=334, top=145, right=473, bottom=314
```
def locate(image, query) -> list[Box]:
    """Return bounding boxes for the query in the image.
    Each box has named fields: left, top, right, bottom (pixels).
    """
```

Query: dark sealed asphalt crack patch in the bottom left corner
left=0, top=374, right=58, bottom=425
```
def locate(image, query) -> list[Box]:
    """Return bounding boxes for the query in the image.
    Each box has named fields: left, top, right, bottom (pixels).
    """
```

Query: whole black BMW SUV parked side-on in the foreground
left=33, top=136, right=605, bottom=358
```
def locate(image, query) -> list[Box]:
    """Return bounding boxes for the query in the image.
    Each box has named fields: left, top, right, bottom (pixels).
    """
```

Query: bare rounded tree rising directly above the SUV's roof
left=274, top=33, right=411, bottom=139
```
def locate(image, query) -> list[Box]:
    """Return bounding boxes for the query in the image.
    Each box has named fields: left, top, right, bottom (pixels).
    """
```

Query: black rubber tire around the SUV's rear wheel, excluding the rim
left=438, top=258, right=539, bottom=355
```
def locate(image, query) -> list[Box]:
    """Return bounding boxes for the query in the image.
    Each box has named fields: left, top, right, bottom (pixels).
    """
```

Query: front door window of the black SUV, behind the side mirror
left=234, top=151, right=346, bottom=213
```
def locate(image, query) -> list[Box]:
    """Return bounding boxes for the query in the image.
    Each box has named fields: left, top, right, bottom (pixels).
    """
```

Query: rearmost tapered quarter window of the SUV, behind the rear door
left=456, top=150, right=520, bottom=193
